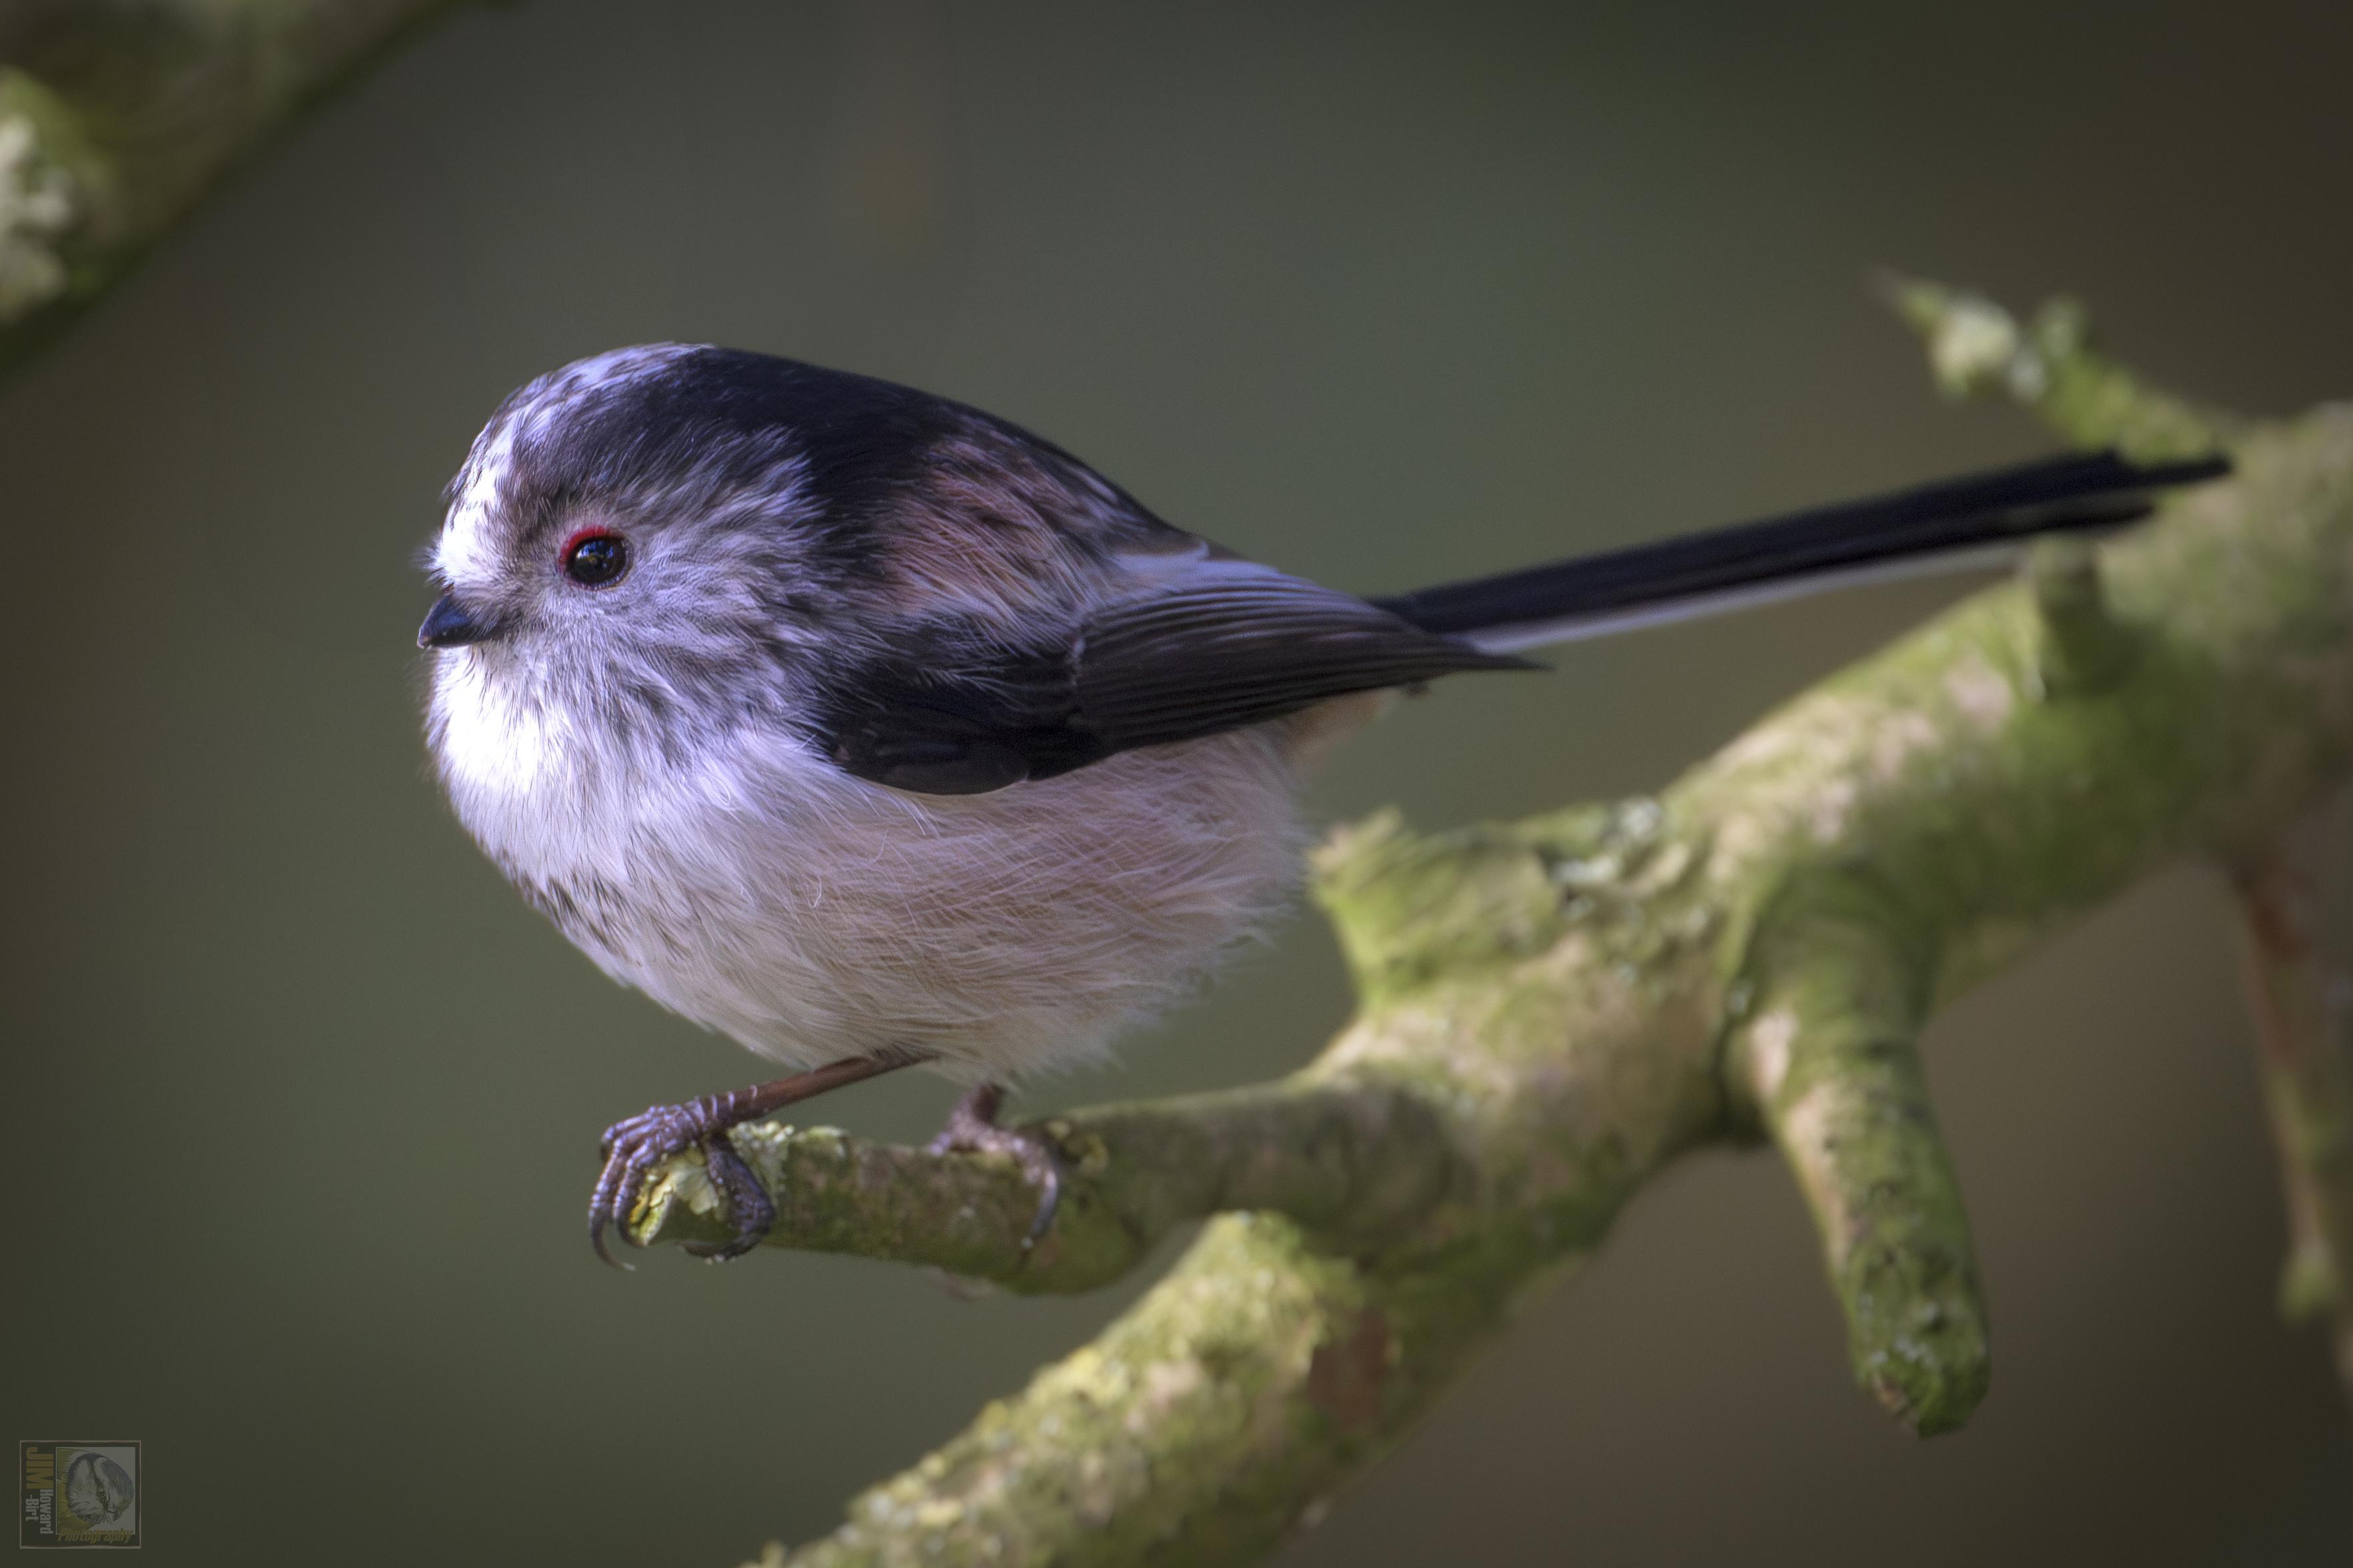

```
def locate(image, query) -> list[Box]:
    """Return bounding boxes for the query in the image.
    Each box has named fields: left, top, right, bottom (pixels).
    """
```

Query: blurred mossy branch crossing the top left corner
left=0, top=0, right=456, bottom=378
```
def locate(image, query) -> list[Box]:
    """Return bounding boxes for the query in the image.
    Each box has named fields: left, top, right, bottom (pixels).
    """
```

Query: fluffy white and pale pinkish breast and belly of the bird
left=433, top=660, right=1299, bottom=1076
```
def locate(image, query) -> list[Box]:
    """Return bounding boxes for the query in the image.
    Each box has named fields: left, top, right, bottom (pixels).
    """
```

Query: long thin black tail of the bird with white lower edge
left=1379, top=452, right=2231, bottom=654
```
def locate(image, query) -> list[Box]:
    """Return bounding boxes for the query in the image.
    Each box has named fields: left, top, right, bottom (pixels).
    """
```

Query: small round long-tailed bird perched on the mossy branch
left=416, top=343, right=2228, bottom=1263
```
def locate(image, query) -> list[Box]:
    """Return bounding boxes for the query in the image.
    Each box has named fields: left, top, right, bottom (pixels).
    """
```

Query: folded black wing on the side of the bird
left=819, top=562, right=1534, bottom=794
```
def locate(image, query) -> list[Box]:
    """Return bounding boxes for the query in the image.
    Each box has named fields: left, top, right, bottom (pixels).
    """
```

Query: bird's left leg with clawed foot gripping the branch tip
left=588, top=1056, right=923, bottom=1267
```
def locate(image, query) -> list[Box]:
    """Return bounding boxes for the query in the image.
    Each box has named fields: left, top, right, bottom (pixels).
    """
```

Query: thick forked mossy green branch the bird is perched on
left=638, top=297, right=2353, bottom=1565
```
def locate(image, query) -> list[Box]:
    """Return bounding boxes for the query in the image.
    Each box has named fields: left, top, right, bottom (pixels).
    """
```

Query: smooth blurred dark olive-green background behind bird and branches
left=0, top=0, right=2353, bottom=1565
